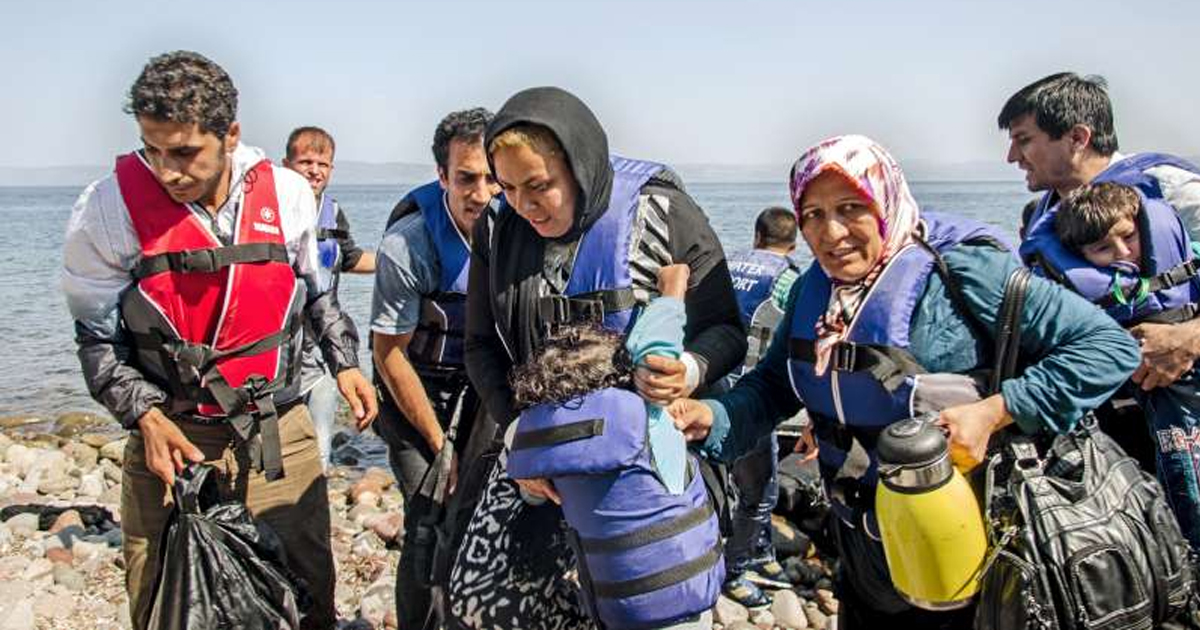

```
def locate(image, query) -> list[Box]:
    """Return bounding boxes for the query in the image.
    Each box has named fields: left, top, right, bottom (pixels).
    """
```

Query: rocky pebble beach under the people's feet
left=0, top=414, right=838, bottom=630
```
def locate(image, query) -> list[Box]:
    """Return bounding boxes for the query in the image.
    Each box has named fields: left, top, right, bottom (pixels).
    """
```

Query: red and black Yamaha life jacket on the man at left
left=116, top=154, right=305, bottom=479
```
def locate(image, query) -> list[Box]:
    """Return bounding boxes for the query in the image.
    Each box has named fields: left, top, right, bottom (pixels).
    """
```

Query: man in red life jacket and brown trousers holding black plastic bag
left=62, top=52, right=376, bottom=629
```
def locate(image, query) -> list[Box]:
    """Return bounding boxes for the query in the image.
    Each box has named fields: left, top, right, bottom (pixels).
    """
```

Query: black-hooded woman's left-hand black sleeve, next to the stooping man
left=463, top=216, right=517, bottom=430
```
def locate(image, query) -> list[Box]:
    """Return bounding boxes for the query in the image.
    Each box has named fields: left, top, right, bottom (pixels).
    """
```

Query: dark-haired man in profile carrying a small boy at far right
left=997, top=72, right=1200, bottom=451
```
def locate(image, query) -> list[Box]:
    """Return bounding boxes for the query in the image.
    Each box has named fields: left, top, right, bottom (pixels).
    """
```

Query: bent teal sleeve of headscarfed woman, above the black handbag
left=944, top=245, right=1140, bottom=433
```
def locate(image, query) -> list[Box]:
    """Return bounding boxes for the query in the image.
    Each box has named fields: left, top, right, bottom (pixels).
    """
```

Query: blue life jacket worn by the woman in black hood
left=538, top=156, right=664, bottom=332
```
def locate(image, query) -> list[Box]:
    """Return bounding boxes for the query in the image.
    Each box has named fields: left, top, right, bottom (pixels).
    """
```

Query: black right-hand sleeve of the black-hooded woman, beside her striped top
left=643, top=186, right=746, bottom=385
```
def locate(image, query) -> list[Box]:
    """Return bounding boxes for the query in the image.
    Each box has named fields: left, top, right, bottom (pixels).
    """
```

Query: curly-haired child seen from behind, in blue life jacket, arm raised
left=508, top=265, right=725, bottom=629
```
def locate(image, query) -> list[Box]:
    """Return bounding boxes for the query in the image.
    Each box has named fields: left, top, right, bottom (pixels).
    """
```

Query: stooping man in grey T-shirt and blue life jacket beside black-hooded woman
left=371, top=108, right=499, bottom=628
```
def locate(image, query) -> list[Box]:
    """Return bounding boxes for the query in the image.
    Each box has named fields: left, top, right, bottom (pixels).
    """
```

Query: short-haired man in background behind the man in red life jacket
left=283, top=126, right=374, bottom=468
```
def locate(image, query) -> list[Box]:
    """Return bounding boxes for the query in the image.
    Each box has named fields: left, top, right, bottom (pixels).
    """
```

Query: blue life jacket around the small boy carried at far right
left=1020, top=154, right=1200, bottom=326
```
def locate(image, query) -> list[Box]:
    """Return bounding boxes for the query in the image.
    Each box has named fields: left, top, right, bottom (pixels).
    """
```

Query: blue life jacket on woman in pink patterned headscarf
left=788, top=212, right=1003, bottom=528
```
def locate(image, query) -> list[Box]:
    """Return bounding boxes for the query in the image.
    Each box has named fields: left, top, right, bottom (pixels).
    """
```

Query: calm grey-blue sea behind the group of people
left=0, top=182, right=1030, bottom=419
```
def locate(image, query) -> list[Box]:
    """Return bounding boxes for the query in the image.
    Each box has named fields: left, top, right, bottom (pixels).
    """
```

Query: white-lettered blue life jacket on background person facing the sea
left=727, top=250, right=798, bottom=373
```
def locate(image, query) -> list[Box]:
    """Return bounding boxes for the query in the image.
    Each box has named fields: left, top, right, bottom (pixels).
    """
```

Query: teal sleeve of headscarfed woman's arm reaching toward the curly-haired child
left=701, top=280, right=802, bottom=462
